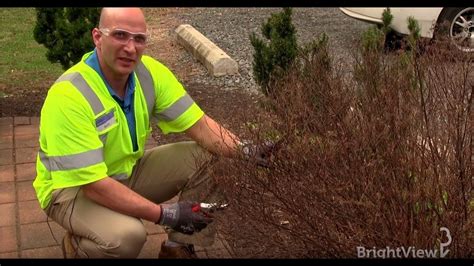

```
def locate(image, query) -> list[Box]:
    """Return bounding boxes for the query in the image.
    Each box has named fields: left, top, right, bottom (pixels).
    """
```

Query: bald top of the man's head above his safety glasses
left=99, top=7, right=146, bottom=32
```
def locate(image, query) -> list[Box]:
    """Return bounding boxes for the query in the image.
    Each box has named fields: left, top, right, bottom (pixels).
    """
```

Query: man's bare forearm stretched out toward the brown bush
left=185, top=115, right=239, bottom=157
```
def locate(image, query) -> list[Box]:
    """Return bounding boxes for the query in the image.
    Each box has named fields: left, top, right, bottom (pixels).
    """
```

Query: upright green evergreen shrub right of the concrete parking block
left=250, top=8, right=298, bottom=95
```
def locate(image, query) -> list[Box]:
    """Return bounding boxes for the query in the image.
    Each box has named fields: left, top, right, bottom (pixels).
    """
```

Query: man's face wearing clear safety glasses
left=93, top=10, right=146, bottom=78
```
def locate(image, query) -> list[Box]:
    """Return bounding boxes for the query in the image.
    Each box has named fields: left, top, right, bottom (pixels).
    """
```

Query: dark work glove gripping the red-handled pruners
left=157, top=201, right=213, bottom=235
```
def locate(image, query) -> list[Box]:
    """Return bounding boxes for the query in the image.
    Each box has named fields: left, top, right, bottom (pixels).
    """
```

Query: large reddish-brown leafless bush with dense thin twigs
left=215, top=9, right=474, bottom=258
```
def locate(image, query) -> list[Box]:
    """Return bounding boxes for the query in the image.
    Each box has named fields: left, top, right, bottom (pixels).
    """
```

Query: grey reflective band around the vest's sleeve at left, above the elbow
left=39, top=148, right=104, bottom=172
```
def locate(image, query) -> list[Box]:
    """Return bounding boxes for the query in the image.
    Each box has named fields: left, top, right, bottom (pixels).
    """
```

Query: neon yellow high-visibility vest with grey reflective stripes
left=33, top=52, right=204, bottom=209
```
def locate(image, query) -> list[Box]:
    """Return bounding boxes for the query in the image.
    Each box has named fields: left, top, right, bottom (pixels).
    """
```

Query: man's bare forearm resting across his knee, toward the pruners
left=82, top=177, right=161, bottom=222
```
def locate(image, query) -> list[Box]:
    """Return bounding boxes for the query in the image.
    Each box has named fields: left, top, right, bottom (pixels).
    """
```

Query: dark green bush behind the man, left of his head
left=34, top=7, right=100, bottom=69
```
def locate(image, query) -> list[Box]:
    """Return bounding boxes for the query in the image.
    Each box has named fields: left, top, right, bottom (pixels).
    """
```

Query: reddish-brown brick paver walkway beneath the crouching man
left=0, top=117, right=231, bottom=258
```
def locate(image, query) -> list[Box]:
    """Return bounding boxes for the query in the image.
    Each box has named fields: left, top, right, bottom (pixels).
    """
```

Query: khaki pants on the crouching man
left=45, top=141, right=219, bottom=258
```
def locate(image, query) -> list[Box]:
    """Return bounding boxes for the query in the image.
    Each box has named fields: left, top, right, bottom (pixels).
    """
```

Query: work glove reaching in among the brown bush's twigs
left=239, top=140, right=276, bottom=167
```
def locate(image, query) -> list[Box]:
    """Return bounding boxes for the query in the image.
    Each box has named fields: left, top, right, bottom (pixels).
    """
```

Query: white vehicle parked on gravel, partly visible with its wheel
left=340, top=7, right=474, bottom=53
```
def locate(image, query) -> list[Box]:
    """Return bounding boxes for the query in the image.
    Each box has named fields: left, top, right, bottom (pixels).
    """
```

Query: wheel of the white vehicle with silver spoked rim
left=436, top=7, right=474, bottom=53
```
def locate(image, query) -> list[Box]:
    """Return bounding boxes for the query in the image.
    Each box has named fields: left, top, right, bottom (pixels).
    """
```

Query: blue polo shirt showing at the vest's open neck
left=86, top=49, right=138, bottom=151
